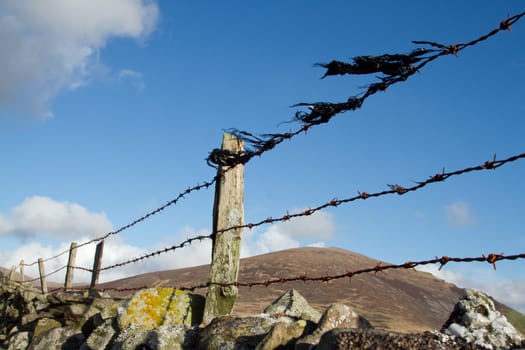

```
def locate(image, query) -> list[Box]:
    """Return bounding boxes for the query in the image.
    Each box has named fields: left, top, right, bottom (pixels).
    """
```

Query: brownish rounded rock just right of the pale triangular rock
left=295, top=303, right=372, bottom=350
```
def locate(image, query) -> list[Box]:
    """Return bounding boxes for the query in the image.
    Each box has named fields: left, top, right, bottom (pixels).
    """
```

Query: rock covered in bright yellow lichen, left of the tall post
left=118, top=287, right=204, bottom=330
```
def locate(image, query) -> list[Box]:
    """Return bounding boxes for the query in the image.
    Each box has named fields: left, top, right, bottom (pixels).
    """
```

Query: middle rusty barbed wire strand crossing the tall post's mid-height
left=94, top=153, right=525, bottom=271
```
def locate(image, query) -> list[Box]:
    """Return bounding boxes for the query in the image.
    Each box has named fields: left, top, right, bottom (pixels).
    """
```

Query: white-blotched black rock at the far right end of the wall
left=442, top=289, right=523, bottom=349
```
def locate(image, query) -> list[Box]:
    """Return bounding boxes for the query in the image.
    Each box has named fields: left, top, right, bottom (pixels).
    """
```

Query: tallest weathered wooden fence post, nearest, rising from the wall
left=203, top=133, right=244, bottom=323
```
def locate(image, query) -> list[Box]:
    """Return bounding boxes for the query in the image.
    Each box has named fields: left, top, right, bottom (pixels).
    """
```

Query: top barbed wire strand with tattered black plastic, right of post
left=207, top=12, right=525, bottom=168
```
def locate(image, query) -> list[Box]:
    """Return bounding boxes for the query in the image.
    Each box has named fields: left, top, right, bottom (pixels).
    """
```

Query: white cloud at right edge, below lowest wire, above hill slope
left=417, top=265, right=525, bottom=313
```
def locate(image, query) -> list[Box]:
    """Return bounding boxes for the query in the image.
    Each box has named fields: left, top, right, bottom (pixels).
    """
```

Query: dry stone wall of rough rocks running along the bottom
left=0, top=279, right=525, bottom=350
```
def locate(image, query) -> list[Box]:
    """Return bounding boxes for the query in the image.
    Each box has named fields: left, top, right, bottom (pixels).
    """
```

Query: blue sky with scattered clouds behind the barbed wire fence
left=0, top=0, right=525, bottom=311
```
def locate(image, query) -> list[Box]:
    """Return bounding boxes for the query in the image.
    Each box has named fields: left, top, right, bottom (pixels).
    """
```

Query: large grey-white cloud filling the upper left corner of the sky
left=0, top=0, right=159, bottom=117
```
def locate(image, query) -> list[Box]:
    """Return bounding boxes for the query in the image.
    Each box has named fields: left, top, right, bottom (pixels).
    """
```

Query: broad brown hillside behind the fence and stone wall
left=98, top=248, right=462, bottom=332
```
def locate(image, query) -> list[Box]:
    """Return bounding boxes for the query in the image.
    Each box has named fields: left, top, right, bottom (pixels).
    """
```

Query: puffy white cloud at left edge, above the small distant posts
left=0, top=196, right=112, bottom=239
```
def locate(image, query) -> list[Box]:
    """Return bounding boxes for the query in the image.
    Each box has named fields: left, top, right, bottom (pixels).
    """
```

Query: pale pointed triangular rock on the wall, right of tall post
left=263, top=289, right=321, bottom=323
